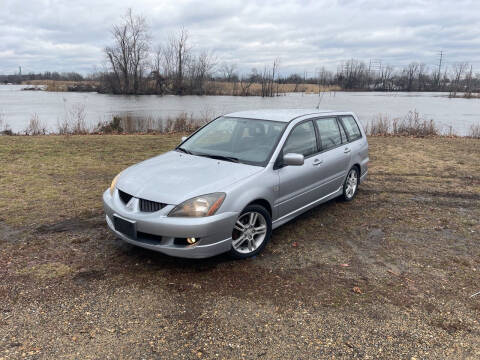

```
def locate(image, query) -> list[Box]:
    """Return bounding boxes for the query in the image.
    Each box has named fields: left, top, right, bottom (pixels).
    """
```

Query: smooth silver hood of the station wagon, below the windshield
left=117, top=151, right=263, bottom=205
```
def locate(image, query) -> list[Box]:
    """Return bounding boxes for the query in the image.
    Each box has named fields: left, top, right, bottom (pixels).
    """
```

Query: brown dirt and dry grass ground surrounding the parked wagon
left=0, top=135, right=480, bottom=359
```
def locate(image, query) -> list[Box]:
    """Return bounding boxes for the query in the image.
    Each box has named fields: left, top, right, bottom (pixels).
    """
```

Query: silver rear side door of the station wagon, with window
left=315, top=117, right=351, bottom=197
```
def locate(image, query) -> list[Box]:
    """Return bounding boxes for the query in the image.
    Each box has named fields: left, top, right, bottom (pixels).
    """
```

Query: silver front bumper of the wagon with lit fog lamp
left=103, top=189, right=238, bottom=258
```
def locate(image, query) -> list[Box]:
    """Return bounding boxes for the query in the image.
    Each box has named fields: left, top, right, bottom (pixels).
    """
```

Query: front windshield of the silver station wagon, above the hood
left=177, top=117, right=287, bottom=166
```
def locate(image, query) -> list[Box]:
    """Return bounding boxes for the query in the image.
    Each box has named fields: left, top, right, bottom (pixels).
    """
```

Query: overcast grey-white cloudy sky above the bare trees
left=0, top=0, right=480, bottom=75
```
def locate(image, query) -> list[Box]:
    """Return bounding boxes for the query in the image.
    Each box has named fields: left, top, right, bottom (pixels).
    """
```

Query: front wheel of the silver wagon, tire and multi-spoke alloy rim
left=229, top=205, right=272, bottom=259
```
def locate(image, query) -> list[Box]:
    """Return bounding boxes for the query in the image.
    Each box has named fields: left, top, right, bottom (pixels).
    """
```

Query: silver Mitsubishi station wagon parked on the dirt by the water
left=103, top=109, right=368, bottom=258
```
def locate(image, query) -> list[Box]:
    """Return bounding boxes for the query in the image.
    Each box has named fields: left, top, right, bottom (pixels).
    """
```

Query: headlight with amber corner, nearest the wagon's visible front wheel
left=168, top=193, right=225, bottom=217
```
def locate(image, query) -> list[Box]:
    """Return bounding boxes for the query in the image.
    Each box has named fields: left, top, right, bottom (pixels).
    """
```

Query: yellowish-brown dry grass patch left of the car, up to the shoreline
left=0, top=135, right=179, bottom=225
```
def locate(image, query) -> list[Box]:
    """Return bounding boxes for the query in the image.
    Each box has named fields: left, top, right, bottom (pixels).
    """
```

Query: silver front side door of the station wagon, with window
left=275, top=120, right=321, bottom=217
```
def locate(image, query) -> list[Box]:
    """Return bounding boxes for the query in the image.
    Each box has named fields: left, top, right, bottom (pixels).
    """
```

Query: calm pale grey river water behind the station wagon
left=0, top=85, right=480, bottom=135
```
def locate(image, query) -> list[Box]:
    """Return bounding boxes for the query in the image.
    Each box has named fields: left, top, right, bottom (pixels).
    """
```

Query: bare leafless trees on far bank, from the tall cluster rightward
left=98, top=10, right=480, bottom=96
